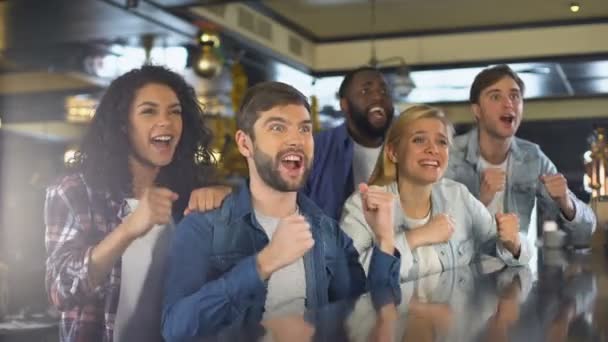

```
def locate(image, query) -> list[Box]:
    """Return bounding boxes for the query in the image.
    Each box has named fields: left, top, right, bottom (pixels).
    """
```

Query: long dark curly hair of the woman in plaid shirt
left=72, top=65, right=213, bottom=217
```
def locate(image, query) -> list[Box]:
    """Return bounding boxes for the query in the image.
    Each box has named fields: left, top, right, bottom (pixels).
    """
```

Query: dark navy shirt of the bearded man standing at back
left=302, top=123, right=355, bottom=221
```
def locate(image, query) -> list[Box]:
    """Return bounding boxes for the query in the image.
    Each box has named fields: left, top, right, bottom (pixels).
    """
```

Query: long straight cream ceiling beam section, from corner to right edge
left=312, top=23, right=608, bottom=72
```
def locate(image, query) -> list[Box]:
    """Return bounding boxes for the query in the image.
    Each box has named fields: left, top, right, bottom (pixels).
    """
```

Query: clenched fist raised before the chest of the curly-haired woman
left=124, top=188, right=178, bottom=239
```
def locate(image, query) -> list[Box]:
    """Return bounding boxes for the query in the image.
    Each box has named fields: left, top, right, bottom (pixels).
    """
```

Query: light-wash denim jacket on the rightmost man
left=446, top=128, right=596, bottom=245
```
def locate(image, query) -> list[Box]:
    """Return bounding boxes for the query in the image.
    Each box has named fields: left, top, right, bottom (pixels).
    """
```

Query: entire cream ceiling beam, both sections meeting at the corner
left=190, top=4, right=608, bottom=75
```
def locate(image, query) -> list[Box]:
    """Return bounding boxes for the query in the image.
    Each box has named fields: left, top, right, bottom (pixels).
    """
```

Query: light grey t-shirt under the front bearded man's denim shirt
left=255, top=210, right=306, bottom=319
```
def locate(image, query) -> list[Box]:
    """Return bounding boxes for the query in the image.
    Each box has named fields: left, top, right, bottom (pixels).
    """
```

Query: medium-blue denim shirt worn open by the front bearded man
left=162, top=180, right=400, bottom=341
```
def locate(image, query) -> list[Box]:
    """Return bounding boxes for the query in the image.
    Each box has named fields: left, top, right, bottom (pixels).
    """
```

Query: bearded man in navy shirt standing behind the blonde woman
left=303, top=67, right=395, bottom=220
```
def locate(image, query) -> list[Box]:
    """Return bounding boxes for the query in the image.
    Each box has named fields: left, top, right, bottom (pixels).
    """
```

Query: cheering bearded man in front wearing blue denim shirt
left=163, top=82, right=400, bottom=341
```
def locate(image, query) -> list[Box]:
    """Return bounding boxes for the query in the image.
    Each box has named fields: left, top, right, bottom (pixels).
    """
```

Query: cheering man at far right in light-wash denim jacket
left=446, top=65, right=596, bottom=250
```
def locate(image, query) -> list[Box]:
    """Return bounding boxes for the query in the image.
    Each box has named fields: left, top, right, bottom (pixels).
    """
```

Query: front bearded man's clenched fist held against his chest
left=257, top=214, right=315, bottom=280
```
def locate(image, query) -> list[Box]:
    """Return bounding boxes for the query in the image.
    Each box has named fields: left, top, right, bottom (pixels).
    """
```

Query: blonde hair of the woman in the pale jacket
left=369, top=105, right=454, bottom=185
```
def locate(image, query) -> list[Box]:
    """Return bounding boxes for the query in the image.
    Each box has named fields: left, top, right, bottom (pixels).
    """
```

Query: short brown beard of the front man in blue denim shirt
left=253, top=146, right=311, bottom=192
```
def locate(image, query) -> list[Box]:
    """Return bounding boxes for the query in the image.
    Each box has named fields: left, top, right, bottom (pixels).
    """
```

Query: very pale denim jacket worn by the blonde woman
left=340, top=179, right=532, bottom=281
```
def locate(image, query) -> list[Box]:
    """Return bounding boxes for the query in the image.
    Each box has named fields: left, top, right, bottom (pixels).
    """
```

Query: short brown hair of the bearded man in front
left=236, top=81, right=310, bottom=139
